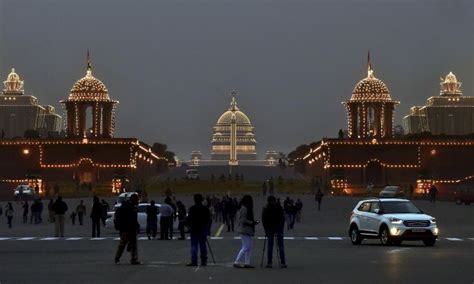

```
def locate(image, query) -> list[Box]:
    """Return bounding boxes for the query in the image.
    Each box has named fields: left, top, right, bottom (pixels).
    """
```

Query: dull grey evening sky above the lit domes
left=0, top=0, right=474, bottom=158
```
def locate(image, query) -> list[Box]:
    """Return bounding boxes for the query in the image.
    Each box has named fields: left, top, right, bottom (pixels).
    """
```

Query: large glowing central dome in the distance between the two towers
left=211, top=91, right=257, bottom=162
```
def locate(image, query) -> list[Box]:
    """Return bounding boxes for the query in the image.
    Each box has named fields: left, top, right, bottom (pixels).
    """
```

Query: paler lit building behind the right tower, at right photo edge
left=403, top=72, right=474, bottom=135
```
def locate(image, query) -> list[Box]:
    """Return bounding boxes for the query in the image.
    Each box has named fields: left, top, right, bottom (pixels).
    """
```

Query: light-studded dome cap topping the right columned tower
left=351, top=68, right=392, bottom=101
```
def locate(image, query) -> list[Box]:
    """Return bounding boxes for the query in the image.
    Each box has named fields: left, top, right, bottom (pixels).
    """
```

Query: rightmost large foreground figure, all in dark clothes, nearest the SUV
left=262, top=196, right=286, bottom=268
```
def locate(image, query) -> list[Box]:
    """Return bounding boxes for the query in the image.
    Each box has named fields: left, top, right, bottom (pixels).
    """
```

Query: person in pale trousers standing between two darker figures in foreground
left=234, top=195, right=258, bottom=268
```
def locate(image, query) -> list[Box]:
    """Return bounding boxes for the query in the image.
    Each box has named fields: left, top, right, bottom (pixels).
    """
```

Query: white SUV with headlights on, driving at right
left=349, top=198, right=438, bottom=246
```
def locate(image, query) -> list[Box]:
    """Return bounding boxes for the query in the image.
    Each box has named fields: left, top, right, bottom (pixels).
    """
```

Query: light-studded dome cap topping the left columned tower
left=69, top=68, right=110, bottom=101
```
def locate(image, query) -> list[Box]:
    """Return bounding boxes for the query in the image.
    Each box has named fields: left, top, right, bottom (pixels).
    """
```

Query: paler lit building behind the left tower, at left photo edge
left=0, top=69, right=61, bottom=138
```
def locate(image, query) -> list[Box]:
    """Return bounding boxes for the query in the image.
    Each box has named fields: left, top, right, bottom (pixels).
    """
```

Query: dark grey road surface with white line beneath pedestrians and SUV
left=0, top=195, right=474, bottom=284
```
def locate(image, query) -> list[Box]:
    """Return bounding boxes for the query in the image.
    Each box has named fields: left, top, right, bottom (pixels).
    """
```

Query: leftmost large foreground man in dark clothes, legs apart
left=115, top=194, right=141, bottom=265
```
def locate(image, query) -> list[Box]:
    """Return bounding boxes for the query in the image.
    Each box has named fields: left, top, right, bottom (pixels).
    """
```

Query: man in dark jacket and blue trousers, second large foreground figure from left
left=187, top=194, right=211, bottom=266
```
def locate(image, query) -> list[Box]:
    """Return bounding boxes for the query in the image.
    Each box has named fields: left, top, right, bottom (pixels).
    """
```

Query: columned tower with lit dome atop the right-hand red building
left=343, top=61, right=399, bottom=138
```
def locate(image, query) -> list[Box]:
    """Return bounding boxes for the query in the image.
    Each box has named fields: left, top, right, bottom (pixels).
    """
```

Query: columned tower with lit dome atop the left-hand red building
left=61, top=62, right=118, bottom=138
